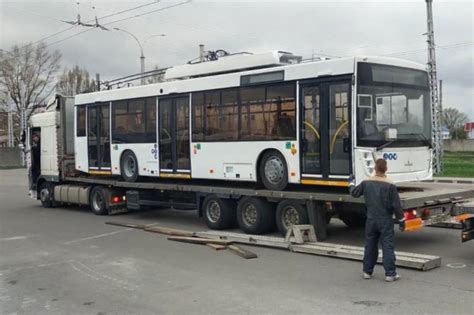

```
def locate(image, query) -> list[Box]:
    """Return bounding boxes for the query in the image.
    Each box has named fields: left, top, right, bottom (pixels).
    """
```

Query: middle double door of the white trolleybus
left=158, top=96, right=191, bottom=178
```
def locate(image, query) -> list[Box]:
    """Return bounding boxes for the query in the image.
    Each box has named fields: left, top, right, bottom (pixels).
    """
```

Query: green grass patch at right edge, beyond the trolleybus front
left=436, top=151, right=474, bottom=178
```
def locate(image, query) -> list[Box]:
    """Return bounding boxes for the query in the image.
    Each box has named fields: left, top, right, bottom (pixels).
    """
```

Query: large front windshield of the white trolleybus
left=356, top=63, right=431, bottom=147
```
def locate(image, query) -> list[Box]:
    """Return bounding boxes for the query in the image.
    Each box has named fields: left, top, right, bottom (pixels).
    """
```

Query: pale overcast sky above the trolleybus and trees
left=0, top=0, right=474, bottom=121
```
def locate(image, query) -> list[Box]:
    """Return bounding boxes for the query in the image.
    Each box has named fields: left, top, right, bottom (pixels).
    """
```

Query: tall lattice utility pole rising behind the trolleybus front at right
left=425, top=0, right=443, bottom=174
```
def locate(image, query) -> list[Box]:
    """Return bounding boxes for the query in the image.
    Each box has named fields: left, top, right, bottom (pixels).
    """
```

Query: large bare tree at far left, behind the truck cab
left=0, top=43, right=61, bottom=142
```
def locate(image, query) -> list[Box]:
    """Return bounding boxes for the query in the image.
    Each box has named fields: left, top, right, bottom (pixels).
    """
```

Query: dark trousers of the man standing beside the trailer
left=363, top=217, right=397, bottom=277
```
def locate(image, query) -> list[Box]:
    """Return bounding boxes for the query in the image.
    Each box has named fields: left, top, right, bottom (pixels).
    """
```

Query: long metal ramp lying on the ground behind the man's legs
left=194, top=231, right=441, bottom=271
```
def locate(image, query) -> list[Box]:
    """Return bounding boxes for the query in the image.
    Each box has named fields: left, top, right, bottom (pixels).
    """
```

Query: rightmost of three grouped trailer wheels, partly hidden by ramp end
left=275, top=200, right=309, bottom=235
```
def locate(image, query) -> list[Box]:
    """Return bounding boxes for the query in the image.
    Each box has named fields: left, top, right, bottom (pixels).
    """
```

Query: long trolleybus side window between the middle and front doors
left=192, top=83, right=296, bottom=141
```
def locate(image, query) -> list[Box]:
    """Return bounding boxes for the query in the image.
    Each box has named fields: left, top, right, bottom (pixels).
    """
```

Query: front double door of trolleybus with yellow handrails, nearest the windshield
left=300, top=79, right=351, bottom=184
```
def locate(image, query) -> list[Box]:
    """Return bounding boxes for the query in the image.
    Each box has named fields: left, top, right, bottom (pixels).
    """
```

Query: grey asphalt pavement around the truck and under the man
left=0, top=170, right=474, bottom=314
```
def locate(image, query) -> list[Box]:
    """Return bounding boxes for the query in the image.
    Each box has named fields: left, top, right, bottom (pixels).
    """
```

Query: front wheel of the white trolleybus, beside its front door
left=259, top=150, right=288, bottom=190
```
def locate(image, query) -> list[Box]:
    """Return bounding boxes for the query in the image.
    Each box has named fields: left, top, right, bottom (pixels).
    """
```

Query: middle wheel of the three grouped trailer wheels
left=237, top=197, right=275, bottom=234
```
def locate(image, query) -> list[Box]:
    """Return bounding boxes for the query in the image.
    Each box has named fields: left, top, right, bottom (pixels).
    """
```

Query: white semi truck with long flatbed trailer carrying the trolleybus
left=25, top=96, right=474, bottom=241
